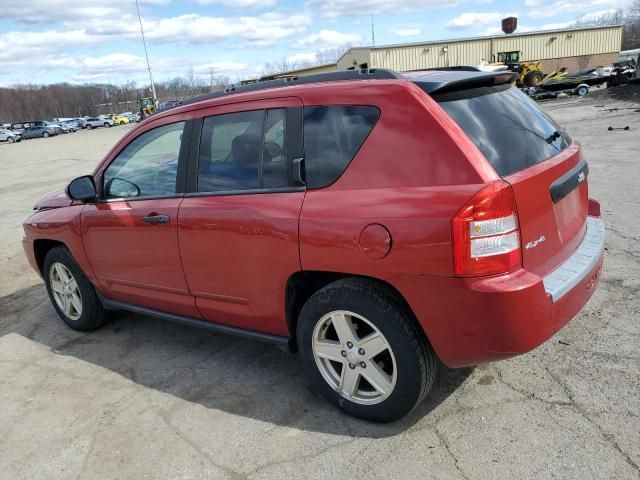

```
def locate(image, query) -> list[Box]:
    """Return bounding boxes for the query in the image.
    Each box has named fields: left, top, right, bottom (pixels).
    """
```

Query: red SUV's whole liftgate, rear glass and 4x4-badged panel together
left=434, top=85, right=588, bottom=275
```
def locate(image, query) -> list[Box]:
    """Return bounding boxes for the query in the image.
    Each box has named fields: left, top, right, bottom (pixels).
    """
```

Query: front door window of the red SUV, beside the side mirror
left=104, top=122, right=185, bottom=198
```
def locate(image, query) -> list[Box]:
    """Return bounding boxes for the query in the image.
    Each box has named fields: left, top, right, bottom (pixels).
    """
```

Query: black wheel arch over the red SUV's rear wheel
left=285, top=270, right=430, bottom=351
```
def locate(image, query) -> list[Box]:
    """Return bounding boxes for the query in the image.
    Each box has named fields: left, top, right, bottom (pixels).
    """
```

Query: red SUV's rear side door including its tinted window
left=178, top=98, right=305, bottom=335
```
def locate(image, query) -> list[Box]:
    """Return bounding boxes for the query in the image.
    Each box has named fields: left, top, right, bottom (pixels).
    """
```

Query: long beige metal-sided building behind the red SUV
left=338, top=25, right=622, bottom=73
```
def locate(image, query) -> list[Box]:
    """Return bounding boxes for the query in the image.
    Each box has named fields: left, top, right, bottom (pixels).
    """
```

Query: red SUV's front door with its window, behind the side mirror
left=82, top=119, right=198, bottom=316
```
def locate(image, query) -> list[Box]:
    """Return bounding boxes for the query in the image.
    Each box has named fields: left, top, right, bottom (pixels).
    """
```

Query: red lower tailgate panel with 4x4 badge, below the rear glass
left=504, top=143, right=589, bottom=276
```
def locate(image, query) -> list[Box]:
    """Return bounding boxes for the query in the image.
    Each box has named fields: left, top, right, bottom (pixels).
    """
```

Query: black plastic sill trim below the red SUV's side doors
left=100, top=296, right=292, bottom=352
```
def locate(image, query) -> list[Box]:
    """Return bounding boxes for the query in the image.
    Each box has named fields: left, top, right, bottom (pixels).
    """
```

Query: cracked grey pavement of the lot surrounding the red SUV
left=0, top=105, right=640, bottom=480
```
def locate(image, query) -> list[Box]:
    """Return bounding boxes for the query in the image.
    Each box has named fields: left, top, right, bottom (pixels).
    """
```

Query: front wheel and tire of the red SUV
left=43, top=247, right=107, bottom=332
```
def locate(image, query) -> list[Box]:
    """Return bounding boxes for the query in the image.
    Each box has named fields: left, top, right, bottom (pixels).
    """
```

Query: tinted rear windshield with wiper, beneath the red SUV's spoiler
left=433, top=85, right=571, bottom=176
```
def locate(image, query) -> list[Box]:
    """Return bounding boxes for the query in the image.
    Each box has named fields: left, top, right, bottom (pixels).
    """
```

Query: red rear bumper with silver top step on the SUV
left=392, top=217, right=604, bottom=367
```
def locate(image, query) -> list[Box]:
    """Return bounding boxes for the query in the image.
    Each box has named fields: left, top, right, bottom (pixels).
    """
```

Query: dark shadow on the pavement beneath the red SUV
left=0, top=284, right=472, bottom=438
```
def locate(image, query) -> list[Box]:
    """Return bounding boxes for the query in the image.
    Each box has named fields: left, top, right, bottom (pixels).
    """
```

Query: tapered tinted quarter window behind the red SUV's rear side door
left=304, top=106, right=380, bottom=188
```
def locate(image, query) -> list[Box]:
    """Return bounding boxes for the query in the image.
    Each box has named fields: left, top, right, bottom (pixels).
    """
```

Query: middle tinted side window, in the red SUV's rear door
left=198, top=109, right=288, bottom=192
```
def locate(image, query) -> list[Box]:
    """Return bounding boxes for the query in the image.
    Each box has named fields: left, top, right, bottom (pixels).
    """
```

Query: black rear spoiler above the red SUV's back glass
left=404, top=70, right=517, bottom=95
